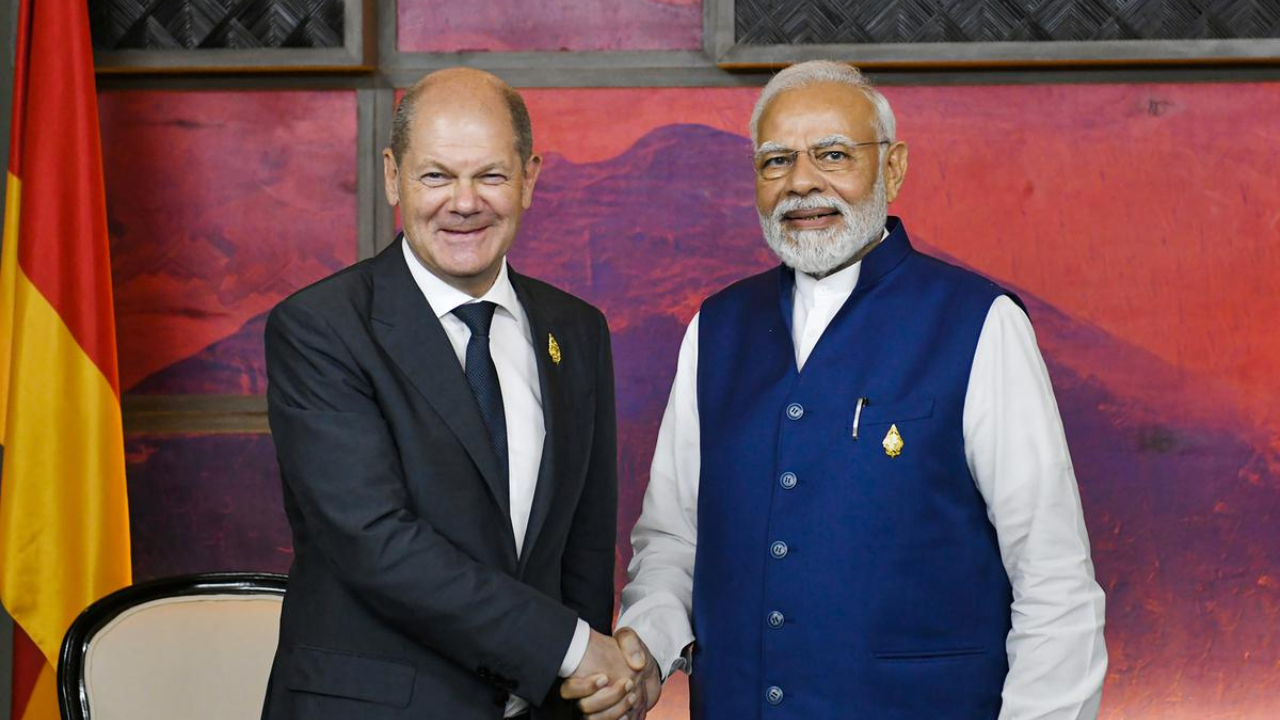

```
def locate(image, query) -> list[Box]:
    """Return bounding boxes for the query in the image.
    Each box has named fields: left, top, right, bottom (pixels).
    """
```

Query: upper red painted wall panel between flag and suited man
left=99, top=91, right=356, bottom=395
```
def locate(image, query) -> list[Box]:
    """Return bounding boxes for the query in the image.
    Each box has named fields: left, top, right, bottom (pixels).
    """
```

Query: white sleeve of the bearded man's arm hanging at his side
left=964, top=297, right=1107, bottom=720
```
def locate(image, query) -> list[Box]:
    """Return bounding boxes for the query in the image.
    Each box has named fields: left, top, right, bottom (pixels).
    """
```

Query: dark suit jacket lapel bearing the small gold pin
left=508, top=265, right=564, bottom=573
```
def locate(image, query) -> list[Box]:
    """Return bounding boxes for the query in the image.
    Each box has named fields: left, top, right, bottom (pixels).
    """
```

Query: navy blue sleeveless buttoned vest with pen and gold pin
left=690, top=218, right=1016, bottom=720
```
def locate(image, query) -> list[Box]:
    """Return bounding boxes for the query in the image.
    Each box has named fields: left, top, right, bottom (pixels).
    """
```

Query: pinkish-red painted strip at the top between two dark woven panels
left=396, top=0, right=703, bottom=53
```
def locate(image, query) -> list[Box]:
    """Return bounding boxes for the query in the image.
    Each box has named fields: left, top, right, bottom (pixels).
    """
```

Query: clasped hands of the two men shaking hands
left=561, top=628, right=662, bottom=720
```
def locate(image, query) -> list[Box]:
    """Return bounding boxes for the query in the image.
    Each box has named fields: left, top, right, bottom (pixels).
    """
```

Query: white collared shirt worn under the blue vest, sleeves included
left=618, top=240, right=1107, bottom=720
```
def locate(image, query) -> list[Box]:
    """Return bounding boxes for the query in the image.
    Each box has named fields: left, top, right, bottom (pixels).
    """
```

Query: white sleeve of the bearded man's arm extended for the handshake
left=618, top=315, right=701, bottom=676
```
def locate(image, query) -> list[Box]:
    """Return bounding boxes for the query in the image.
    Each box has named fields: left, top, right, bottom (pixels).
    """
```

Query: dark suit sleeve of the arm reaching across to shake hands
left=266, top=297, right=577, bottom=698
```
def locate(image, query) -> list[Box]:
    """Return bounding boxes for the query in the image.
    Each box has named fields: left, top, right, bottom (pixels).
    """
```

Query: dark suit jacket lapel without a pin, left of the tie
left=372, top=240, right=516, bottom=543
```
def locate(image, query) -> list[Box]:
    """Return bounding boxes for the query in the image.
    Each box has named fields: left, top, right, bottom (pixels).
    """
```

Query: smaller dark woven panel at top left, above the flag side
left=90, top=0, right=343, bottom=50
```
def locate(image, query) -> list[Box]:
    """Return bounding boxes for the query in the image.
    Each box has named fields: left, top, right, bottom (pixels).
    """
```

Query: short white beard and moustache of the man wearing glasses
left=756, top=173, right=888, bottom=278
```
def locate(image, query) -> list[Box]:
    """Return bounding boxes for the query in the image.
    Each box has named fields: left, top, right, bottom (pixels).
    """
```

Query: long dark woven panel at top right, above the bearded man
left=733, top=0, right=1280, bottom=45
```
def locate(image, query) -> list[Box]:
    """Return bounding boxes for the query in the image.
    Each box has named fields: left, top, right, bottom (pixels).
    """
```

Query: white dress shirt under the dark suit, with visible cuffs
left=401, top=240, right=590, bottom=717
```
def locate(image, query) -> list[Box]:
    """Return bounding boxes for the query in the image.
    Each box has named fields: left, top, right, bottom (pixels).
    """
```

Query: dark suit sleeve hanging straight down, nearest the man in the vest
left=561, top=304, right=618, bottom=634
